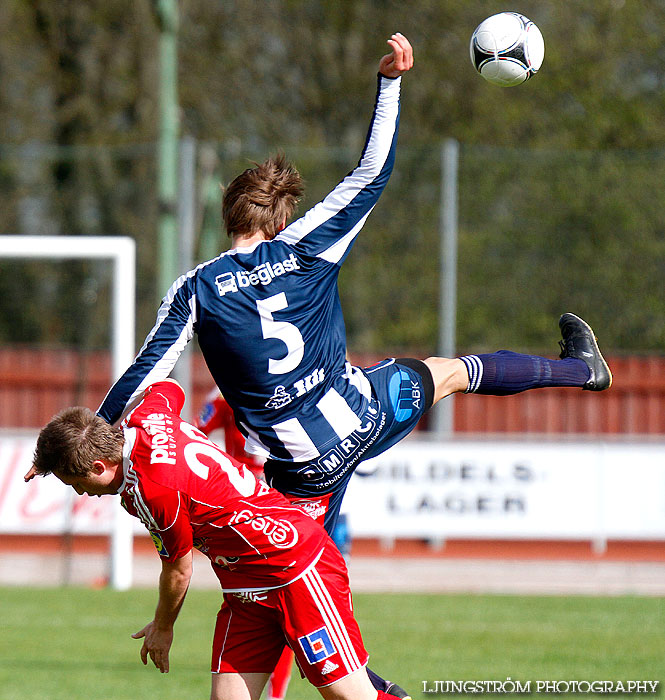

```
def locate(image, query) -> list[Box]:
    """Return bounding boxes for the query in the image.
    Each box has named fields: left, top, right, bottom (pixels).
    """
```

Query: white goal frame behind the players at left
left=0, top=235, right=136, bottom=591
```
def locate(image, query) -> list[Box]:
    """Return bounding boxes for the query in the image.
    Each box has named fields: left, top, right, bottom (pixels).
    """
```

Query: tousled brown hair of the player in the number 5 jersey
left=222, top=154, right=304, bottom=239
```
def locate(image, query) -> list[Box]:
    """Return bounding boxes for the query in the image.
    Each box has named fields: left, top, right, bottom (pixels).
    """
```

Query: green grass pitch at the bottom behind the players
left=0, top=588, right=665, bottom=700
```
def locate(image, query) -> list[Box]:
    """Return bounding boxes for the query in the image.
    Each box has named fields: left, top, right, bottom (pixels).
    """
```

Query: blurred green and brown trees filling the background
left=0, top=0, right=665, bottom=353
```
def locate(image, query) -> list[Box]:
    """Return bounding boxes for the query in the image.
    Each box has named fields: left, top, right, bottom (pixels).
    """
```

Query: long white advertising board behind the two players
left=0, top=434, right=665, bottom=540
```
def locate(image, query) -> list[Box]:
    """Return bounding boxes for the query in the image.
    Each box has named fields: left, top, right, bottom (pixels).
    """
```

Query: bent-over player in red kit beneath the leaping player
left=25, top=380, right=391, bottom=700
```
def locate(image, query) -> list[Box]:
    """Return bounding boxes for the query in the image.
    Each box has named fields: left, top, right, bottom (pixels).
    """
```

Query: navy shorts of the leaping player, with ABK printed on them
left=264, top=358, right=434, bottom=533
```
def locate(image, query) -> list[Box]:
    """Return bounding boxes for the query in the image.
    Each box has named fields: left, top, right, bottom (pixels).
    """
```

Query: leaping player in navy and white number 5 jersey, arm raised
left=99, top=34, right=611, bottom=700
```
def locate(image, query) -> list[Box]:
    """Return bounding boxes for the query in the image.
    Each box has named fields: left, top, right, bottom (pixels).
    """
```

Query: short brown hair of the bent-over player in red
left=33, top=406, right=125, bottom=477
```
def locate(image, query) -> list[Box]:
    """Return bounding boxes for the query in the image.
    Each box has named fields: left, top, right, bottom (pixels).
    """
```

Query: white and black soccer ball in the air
left=469, top=12, right=545, bottom=87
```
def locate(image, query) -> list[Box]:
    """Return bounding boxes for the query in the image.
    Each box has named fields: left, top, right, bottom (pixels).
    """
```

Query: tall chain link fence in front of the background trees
left=0, top=138, right=665, bottom=355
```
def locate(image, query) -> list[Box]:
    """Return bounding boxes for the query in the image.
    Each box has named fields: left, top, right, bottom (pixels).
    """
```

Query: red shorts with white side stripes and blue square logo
left=211, top=540, right=368, bottom=688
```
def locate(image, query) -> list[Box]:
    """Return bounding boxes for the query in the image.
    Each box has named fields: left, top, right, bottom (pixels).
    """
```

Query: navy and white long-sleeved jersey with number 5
left=98, top=76, right=401, bottom=462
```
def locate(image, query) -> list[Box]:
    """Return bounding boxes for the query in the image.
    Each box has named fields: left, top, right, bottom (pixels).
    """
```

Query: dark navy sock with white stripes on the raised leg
left=460, top=350, right=589, bottom=396
